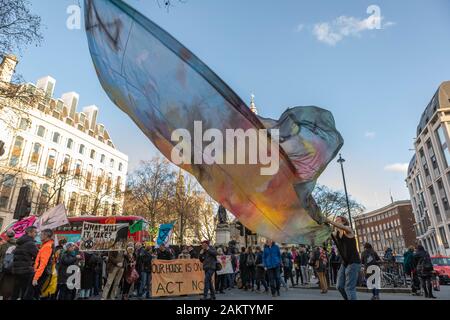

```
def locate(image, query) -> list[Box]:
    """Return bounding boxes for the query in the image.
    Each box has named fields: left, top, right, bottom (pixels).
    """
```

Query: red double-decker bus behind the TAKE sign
left=55, top=216, right=150, bottom=242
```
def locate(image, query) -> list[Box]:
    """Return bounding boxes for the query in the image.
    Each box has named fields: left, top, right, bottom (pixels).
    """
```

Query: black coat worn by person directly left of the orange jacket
left=13, top=234, right=38, bottom=275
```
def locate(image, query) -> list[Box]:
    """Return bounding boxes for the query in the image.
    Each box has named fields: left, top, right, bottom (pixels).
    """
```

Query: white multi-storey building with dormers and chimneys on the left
left=0, top=56, right=128, bottom=228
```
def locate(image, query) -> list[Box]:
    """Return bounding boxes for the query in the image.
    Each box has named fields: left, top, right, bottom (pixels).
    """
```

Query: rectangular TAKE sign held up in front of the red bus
left=80, top=222, right=128, bottom=251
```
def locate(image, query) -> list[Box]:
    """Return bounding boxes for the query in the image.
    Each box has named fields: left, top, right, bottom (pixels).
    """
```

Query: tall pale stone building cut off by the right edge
left=406, top=81, right=450, bottom=255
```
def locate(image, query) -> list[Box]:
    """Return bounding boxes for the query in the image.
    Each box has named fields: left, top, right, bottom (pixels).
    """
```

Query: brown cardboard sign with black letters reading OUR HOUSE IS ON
left=152, top=259, right=205, bottom=297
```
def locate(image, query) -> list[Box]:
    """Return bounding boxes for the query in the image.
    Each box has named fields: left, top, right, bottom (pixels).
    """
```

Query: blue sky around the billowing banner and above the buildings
left=14, top=0, right=450, bottom=209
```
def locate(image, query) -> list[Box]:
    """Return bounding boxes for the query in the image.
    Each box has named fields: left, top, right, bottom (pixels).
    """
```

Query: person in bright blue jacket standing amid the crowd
left=263, top=239, right=281, bottom=297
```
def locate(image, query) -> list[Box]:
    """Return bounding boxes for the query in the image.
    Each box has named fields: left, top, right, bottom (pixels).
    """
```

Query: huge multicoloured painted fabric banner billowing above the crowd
left=85, top=0, right=343, bottom=245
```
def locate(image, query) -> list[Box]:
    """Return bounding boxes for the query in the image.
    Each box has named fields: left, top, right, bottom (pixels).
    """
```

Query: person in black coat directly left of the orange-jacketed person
left=12, top=227, right=39, bottom=300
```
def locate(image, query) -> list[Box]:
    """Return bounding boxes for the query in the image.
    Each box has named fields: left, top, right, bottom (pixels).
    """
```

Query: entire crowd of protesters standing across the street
left=0, top=217, right=442, bottom=300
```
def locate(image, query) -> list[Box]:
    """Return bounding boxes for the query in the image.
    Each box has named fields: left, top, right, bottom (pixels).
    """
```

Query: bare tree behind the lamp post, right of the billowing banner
left=313, top=185, right=365, bottom=218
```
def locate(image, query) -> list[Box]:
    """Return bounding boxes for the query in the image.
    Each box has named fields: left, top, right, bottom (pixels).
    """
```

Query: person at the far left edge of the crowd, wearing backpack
left=0, top=231, right=16, bottom=300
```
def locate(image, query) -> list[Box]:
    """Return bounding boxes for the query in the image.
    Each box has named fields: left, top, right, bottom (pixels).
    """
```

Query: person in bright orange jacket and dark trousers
left=32, top=229, right=54, bottom=300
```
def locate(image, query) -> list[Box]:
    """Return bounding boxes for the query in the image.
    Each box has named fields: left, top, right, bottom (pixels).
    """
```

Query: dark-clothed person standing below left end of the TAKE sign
left=57, top=242, right=81, bottom=300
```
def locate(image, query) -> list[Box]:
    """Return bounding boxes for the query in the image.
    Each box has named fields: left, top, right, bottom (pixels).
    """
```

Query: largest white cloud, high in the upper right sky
left=313, top=16, right=395, bottom=46
